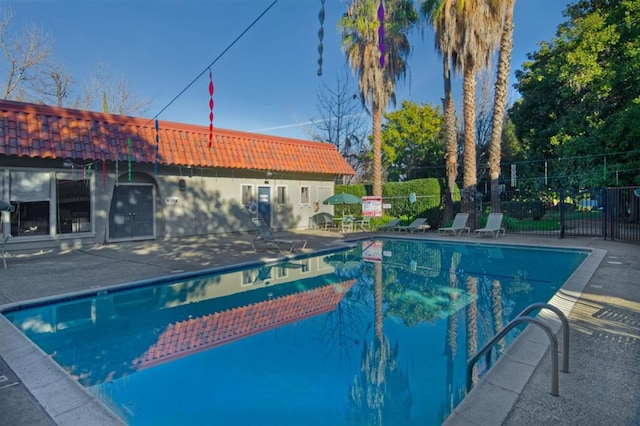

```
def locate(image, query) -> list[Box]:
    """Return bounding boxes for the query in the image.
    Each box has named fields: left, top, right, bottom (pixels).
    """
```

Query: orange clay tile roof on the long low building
left=0, top=101, right=355, bottom=175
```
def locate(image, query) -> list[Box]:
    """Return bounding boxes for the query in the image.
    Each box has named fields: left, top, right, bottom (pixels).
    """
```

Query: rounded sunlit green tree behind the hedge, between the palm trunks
left=382, top=101, right=444, bottom=181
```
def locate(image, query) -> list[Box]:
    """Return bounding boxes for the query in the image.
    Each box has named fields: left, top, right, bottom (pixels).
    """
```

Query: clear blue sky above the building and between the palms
left=10, top=0, right=573, bottom=139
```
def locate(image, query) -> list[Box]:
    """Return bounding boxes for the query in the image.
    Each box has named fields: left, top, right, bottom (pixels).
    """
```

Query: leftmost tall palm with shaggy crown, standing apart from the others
left=338, top=0, right=418, bottom=196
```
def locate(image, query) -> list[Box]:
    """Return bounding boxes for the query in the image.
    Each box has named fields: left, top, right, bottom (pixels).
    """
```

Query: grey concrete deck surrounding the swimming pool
left=0, top=231, right=640, bottom=426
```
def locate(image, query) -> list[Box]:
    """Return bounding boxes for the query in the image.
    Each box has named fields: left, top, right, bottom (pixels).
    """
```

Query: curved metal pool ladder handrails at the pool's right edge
left=467, top=303, right=569, bottom=396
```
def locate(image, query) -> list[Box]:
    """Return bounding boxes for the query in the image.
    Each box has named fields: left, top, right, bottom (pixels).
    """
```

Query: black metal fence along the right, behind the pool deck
left=480, top=188, right=640, bottom=242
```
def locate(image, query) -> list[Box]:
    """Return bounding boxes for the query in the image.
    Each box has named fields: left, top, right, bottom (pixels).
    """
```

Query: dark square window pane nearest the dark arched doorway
left=56, top=178, right=91, bottom=234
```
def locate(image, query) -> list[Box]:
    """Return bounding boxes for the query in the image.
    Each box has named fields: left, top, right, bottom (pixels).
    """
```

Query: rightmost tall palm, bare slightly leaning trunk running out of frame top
left=489, top=0, right=516, bottom=213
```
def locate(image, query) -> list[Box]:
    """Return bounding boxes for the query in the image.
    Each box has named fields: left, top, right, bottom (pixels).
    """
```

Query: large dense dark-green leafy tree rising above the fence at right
left=510, top=0, right=640, bottom=187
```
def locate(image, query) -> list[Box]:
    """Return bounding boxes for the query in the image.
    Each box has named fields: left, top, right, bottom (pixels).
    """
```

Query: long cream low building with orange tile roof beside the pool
left=0, top=101, right=355, bottom=249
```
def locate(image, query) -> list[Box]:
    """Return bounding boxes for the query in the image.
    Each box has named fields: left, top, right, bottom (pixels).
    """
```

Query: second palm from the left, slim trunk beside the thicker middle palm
left=420, top=0, right=458, bottom=222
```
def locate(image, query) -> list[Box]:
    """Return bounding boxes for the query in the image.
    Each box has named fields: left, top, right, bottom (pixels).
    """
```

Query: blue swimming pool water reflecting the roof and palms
left=5, top=239, right=587, bottom=425
